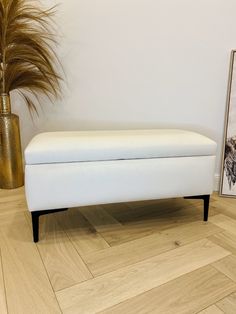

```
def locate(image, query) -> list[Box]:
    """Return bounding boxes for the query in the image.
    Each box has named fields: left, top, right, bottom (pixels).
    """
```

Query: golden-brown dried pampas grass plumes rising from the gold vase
left=0, top=0, right=61, bottom=112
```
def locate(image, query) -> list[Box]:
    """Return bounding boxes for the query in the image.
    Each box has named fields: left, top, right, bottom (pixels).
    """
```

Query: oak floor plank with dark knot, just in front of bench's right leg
left=84, top=222, right=222, bottom=276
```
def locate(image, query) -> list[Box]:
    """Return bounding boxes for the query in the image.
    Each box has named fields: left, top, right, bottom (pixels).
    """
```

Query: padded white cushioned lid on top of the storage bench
left=25, top=129, right=216, bottom=165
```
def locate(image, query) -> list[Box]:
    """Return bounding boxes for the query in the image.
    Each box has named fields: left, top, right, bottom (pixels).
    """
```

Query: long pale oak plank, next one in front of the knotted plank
left=56, top=239, right=230, bottom=314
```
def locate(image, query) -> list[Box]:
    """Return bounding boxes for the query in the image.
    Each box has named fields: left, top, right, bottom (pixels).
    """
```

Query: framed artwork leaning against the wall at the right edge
left=219, top=50, right=236, bottom=198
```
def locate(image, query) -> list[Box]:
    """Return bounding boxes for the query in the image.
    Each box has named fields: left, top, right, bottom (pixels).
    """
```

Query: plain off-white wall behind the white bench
left=13, top=0, right=236, bottom=186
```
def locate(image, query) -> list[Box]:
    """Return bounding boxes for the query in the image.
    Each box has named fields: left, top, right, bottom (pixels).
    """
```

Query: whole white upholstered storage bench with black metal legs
left=25, top=129, right=216, bottom=242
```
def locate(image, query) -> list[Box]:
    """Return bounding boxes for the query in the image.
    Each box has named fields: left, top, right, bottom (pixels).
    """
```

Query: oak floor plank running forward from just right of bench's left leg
left=33, top=214, right=93, bottom=291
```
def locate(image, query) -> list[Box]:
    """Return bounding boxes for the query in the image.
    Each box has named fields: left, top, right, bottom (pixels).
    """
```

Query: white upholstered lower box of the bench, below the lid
left=25, top=156, right=215, bottom=210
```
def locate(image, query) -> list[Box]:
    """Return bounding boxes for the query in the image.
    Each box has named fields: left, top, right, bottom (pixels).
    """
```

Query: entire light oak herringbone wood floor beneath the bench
left=0, top=188, right=236, bottom=314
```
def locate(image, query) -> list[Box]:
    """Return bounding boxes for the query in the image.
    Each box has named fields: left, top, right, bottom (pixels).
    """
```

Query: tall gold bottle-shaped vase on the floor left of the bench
left=0, top=94, right=24, bottom=189
